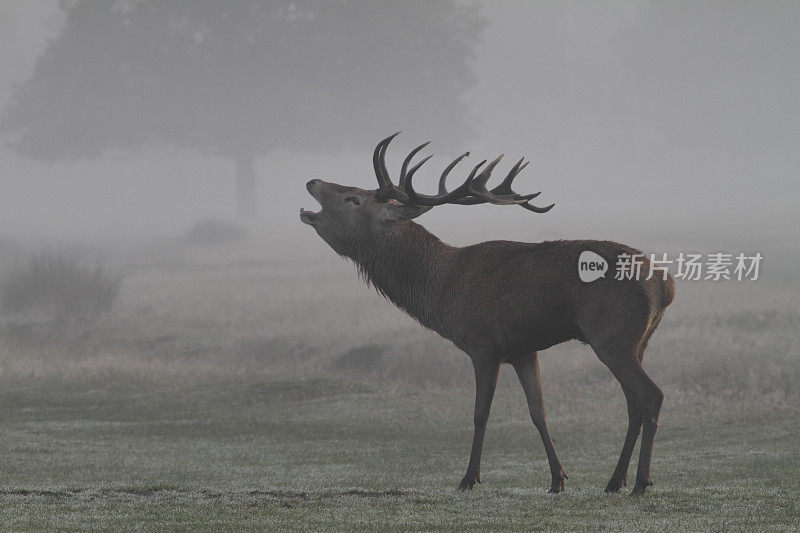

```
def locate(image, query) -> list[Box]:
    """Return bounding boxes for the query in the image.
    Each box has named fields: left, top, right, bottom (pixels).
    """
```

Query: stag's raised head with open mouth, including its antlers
left=300, top=132, right=555, bottom=259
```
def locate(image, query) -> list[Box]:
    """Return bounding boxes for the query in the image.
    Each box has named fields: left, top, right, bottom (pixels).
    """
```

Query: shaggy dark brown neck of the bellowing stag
left=356, top=221, right=455, bottom=331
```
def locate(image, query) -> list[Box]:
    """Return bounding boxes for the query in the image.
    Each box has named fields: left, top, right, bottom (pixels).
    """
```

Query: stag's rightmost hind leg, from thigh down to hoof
left=595, top=340, right=664, bottom=495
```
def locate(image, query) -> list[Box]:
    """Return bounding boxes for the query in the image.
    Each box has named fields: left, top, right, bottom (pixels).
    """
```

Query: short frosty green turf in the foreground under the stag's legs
left=0, top=377, right=800, bottom=530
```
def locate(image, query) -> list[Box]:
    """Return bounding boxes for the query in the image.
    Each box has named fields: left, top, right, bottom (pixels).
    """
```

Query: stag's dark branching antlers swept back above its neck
left=372, top=131, right=555, bottom=213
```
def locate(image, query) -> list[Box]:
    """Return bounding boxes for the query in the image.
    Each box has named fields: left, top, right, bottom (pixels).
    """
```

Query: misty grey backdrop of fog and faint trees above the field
left=0, top=0, right=800, bottom=258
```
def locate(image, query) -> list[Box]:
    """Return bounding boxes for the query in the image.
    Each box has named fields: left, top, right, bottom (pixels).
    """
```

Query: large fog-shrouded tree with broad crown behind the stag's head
left=4, top=0, right=484, bottom=216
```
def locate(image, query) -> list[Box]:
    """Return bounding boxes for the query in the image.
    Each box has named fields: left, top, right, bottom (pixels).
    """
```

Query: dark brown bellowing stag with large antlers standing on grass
left=300, top=132, right=675, bottom=495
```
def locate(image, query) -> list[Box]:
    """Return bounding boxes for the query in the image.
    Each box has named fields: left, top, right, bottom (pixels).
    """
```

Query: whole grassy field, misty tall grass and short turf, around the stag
left=0, top=237, right=800, bottom=530
